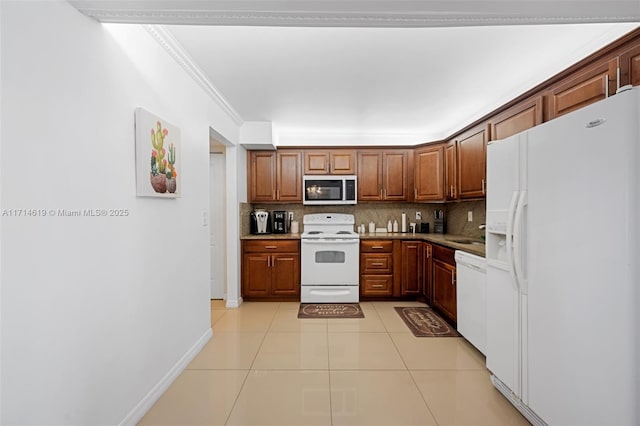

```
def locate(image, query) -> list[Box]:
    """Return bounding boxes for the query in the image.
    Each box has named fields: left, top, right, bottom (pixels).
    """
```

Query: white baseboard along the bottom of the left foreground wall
left=120, top=328, right=213, bottom=426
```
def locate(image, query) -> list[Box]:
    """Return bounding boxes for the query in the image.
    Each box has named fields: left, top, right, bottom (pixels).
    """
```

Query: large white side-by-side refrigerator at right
left=486, top=89, right=640, bottom=426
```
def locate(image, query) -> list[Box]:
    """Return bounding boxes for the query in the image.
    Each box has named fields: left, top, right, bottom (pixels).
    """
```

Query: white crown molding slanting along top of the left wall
left=144, top=25, right=244, bottom=126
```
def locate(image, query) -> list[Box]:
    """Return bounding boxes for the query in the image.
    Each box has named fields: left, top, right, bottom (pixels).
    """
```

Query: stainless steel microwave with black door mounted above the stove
left=302, top=175, right=358, bottom=205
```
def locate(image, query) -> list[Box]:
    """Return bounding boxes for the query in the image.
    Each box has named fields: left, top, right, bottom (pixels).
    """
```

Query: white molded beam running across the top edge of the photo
left=68, top=0, right=640, bottom=28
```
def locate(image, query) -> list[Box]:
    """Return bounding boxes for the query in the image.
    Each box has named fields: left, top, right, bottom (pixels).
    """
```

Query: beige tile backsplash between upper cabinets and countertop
left=240, top=200, right=485, bottom=238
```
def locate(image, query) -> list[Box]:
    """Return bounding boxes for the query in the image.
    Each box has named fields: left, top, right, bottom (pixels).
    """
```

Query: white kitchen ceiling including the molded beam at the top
left=71, top=0, right=640, bottom=146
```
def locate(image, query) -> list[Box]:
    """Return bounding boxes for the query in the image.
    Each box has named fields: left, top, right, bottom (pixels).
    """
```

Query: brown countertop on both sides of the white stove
left=240, top=232, right=485, bottom=257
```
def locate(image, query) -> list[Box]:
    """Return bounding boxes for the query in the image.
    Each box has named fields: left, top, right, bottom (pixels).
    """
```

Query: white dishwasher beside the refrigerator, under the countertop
left=456, top=250, right=487, bottom=354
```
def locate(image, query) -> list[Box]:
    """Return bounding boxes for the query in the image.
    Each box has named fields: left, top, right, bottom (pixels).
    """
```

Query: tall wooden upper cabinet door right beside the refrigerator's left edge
left=458, top=126, right=487, bottom=198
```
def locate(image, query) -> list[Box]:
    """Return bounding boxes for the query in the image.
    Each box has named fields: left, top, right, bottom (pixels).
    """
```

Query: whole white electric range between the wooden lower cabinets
left=300, top=213, right=360, bottom=303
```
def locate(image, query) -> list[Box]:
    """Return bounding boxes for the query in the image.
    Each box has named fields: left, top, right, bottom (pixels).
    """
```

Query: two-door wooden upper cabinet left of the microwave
left=248, top=151, right=302, bottom=203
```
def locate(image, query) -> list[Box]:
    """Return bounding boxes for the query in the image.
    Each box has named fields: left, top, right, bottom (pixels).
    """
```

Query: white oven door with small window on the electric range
left=300, top=238, right=360, bottom=286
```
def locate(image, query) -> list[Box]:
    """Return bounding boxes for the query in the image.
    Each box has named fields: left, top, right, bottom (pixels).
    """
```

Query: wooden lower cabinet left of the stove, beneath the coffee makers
left=241, top=239, right=300, bottom=300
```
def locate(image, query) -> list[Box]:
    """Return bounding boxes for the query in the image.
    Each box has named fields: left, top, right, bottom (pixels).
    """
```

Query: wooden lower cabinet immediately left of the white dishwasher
left=431, top=244, right=458, bottom=324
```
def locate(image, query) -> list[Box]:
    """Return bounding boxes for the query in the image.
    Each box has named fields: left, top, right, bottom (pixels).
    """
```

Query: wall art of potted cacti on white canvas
left=135, top=108, right=182, bottom=198
